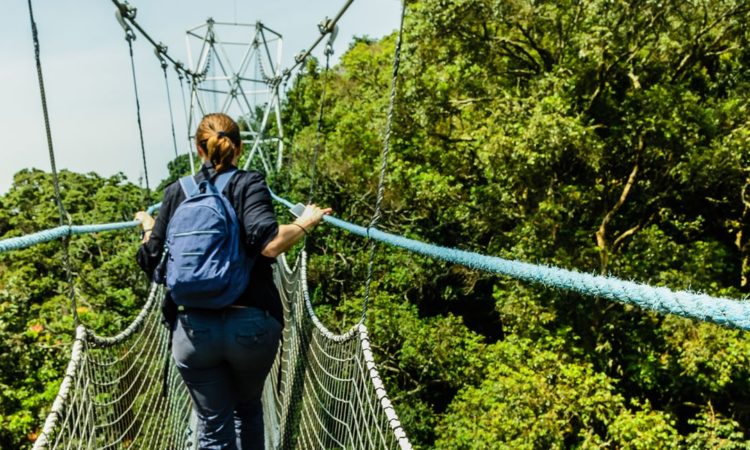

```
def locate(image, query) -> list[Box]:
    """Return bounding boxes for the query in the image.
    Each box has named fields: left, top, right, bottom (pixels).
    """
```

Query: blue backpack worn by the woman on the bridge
left=166, top=169, right=251, bottom=309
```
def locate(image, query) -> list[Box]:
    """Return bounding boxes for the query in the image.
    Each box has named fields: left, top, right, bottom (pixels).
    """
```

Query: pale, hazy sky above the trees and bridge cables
left=0, top=0, right=401, bottom=194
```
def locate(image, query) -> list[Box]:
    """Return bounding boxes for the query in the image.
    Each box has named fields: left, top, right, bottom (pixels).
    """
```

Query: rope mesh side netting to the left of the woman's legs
left=34, top=284, right=192, bottom=450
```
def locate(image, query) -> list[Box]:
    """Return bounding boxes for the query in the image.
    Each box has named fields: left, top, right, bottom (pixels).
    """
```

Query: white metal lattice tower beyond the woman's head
left=185, top=19, right=284, bottom=173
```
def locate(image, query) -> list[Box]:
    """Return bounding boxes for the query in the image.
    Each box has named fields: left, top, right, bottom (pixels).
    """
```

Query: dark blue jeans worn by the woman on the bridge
left=172, top=307, right=282, bottom=450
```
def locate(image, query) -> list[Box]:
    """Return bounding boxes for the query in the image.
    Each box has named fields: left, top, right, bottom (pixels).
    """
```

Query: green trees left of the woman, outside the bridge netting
left=0, top=170, right=147, bottom=449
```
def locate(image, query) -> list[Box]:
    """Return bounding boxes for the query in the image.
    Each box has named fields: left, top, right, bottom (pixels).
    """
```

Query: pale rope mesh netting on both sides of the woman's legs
left=34, top=248, right=411, bottom=450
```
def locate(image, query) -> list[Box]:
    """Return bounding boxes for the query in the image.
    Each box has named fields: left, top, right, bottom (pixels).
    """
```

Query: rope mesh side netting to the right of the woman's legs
left=264, top=252, right=411, bottom=449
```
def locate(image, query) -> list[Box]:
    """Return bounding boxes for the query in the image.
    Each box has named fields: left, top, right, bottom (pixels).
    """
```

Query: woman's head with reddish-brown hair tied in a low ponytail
left=195, top=113, right=242, bottom=172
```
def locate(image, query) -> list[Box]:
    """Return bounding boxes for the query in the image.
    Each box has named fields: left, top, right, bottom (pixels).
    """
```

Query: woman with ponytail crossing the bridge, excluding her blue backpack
left=136, top=114, right=331, bottom=450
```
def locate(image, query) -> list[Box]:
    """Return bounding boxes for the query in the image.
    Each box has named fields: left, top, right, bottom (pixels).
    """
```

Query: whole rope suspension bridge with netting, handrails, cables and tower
left=5, top=0, right=750, bottom=449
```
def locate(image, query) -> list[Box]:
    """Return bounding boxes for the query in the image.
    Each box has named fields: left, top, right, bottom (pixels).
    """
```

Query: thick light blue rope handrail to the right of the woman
left=271, top=192, right=750, bottom=330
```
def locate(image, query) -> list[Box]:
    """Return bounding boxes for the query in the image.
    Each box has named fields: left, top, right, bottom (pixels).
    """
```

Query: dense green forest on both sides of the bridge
left=0, top=0, right=750, bottom=450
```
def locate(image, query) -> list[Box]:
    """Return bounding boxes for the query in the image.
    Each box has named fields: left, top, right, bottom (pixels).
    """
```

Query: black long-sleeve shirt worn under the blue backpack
left=136, top=163, right=284, bottom=323
